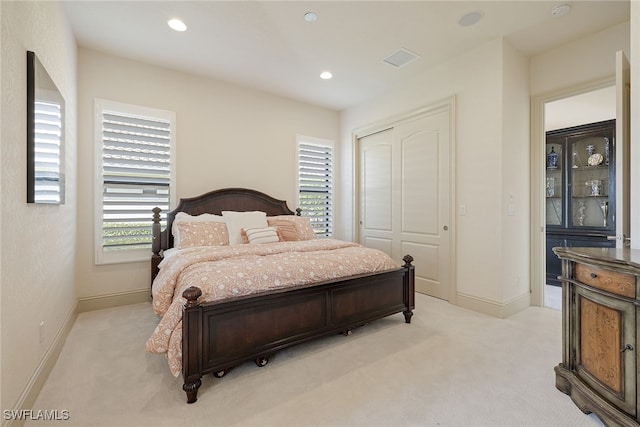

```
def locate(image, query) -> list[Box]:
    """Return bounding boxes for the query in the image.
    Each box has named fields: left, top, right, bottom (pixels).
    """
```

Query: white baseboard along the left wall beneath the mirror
left=2, top=303, right=78, bottom=427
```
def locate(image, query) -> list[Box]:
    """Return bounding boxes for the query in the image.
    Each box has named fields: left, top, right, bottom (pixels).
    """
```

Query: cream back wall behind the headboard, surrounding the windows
left=77, top=49, right=339, bottom=304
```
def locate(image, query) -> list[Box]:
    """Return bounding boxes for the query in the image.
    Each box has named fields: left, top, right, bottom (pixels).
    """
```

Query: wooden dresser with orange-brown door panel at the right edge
left=553, top=247, right=640, bottom=426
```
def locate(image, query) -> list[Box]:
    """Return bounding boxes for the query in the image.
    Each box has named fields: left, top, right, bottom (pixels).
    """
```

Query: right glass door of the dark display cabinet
left=568, top=134, right=615, bottom=228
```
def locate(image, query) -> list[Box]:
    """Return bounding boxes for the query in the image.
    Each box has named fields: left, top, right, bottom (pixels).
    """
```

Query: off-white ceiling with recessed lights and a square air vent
left=64, top=0, right=629, bottom=110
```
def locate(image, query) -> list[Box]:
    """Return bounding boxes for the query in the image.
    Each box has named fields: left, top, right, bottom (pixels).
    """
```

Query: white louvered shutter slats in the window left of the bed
left=102, top=111, right=171, bottom=251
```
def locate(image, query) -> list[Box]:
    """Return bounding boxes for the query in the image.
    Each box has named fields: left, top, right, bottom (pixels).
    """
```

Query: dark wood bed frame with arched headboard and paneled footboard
left=151, top=188, right=415, bottom=403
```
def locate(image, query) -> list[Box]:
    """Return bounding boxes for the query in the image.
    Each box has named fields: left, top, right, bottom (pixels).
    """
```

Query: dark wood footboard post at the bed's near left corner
left=182, top=286, right=203, bottom=403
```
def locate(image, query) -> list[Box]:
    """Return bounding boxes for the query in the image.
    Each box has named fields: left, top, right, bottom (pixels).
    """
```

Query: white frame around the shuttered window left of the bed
left=94, top=99, right=176, bottom=265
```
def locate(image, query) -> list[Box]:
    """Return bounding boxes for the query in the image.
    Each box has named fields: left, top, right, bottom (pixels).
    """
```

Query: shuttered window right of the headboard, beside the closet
left=297, top=136, right=333, bottom=237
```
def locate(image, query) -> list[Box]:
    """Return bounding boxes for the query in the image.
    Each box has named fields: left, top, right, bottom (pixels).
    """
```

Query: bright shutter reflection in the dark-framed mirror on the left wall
left=34, top=100, right=64, bottom=203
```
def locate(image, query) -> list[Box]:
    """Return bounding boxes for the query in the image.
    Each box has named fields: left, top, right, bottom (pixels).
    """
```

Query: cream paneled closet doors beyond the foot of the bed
left=358, top=110, right=452, bottom=300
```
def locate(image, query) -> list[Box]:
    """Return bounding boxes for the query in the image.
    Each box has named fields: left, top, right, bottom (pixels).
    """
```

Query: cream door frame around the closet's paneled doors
left=351, top=96, right=457, bottom=305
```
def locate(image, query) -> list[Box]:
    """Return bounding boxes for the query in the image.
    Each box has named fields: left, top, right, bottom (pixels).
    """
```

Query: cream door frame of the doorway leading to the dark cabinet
left=529, top=75, right=616, bottom=307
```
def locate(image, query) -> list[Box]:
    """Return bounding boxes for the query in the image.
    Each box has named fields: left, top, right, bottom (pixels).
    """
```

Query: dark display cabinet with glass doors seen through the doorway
left=545, top=120, right=616, bottom=285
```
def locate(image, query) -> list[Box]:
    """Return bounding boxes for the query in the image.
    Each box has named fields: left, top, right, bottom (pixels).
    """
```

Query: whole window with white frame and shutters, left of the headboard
left=95, top=100, right=175, bottom=264
